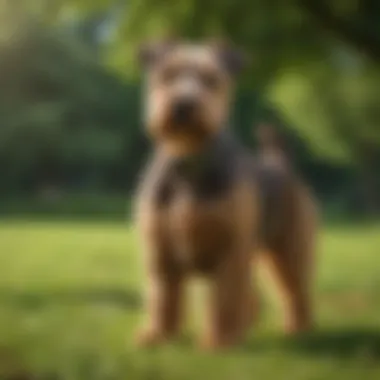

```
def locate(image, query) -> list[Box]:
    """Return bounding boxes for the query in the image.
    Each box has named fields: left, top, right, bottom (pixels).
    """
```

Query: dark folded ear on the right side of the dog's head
left=212, top=41, right=248, bottom=76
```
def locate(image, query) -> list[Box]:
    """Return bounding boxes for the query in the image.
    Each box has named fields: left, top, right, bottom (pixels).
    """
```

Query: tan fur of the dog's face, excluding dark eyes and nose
left=145, top=45, right=232, bottom=154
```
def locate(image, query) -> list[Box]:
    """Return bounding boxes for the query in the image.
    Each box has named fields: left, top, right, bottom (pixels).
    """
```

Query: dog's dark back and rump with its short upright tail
left=255, top=126, right=315, bottom=250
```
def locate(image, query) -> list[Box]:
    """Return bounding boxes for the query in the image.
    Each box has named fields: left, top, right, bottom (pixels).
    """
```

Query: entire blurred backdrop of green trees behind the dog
left=0, top=0, right=380, bottom=215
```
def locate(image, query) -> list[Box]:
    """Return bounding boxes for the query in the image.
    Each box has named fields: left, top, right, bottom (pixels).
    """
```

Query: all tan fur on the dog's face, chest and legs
left=137, top=45, right=316, bottom=349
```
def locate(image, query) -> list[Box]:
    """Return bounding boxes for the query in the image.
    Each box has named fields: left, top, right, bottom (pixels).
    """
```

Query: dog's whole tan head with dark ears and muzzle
left=140, top=42, right=243, bottom=154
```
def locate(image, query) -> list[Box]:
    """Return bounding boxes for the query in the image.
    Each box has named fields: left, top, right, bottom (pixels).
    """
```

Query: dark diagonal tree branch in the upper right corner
left=298, top=0, right=380, bottom=62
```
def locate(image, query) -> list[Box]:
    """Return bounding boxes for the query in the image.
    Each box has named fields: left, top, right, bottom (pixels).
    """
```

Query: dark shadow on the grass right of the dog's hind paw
left=244, top=327, right=380, bottom=360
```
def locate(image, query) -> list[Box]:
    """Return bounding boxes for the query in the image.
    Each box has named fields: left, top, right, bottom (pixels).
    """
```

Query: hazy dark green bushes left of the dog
left=0, top=17, right=145, bottom=191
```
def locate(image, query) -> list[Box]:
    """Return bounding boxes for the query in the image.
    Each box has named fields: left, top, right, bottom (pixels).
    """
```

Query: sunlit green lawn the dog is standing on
left=0, top=221, right=380, bottom=380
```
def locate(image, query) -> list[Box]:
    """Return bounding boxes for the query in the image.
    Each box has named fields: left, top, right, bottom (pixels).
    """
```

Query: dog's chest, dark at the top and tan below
left=160, top=159, right=234, bottom=272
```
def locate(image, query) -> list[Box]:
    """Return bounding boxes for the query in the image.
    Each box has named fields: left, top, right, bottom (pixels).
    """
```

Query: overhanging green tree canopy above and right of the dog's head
left=65, top=0, right=380, bottom=162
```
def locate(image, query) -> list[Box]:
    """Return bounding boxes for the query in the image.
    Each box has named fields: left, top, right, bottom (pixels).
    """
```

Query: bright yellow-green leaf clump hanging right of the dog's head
left=270, top=62, right=380, bottom=164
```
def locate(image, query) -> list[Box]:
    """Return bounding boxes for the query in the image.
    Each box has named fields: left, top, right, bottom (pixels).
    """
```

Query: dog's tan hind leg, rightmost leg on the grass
left=262, top=185, right=318, bottom=334
